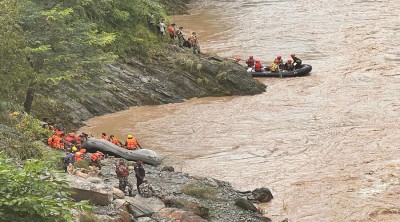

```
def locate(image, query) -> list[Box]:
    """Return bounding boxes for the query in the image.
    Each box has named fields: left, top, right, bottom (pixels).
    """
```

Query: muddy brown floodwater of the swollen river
left=81, top=0, right=400, bottom=222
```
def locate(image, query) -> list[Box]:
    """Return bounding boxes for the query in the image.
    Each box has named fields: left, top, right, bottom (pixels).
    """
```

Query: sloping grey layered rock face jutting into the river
left=35, top=48, right=266, bottom=128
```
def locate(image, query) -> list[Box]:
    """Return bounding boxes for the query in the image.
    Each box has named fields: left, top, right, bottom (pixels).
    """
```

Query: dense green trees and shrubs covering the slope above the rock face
left=0, top=0, right=166, bottom=113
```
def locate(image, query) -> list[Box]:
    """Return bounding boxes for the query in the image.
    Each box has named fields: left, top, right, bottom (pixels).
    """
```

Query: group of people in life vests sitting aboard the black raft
left=246, top=54, right=302, bottom=72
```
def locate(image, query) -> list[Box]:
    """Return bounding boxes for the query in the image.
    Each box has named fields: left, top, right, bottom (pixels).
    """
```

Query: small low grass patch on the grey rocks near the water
left=182, top=183, right=218, bottom=200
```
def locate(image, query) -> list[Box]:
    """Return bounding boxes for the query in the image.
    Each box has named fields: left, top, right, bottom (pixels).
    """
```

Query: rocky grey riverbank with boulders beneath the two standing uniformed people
left=67, top=157, right=273, bottom=222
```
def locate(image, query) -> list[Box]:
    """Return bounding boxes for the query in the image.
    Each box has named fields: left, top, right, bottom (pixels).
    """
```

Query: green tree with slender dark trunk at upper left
left=1, top=0, right=115, bottom=113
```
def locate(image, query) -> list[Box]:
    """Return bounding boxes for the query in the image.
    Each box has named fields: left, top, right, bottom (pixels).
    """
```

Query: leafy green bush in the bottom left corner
left=0, top=153, right=91, bottom=222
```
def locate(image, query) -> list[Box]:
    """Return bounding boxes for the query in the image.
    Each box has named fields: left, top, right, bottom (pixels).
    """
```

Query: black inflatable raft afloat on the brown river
left=247, top=64, right=312, bottom=77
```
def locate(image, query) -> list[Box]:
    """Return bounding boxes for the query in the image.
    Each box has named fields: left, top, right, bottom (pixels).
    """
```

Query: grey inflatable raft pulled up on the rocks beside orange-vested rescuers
left=82, top=137, right=162, bottom=166
